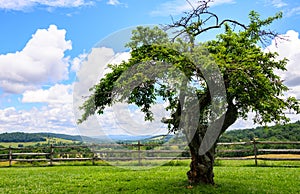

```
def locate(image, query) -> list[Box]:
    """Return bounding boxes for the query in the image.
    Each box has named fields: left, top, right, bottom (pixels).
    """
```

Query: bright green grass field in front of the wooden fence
left=0, top=161, right=300, bottom=194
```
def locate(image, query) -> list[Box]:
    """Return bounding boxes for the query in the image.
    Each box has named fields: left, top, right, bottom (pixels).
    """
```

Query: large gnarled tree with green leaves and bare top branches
left=79, top=0, right=299, bottom=184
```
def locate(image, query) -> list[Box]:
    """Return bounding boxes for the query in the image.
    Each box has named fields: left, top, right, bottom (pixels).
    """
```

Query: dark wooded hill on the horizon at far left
left=0, top=132, right=47, bottom=142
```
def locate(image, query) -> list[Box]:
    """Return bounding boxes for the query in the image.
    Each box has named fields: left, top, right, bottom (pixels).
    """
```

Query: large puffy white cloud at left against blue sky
left=0, top=25, right=72, bottom=93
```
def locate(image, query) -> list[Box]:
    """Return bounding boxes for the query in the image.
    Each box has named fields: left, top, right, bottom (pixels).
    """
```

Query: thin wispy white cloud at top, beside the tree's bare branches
left=150, top=0, right=235, bottom=16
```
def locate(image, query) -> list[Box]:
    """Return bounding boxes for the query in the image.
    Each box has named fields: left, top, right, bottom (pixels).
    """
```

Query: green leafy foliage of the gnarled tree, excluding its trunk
left=78, top=12, right=299, bottom=136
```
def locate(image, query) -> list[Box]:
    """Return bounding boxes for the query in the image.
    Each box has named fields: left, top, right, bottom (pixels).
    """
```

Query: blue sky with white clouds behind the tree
left=0, top=0, right=300, bottom=135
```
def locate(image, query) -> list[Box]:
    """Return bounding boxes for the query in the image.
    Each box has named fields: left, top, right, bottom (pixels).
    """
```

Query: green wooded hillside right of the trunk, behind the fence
left=219, top=121, right=300, bottom=142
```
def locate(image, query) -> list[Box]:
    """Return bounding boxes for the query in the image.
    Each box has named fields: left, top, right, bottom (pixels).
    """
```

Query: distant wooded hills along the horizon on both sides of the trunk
left=0, top=121, right=300, bottom=143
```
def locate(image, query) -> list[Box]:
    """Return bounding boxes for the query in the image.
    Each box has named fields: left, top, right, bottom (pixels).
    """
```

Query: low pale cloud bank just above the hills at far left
left=0, top=104, right=79, bottom=134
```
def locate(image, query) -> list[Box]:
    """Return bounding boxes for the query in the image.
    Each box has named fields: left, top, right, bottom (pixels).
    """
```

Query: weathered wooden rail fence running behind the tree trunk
left=0, top=141, right=300, bottom=166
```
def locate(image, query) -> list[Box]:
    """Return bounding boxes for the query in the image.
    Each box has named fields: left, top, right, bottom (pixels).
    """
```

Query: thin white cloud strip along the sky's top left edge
left=0, top=0, right=93, bottom=11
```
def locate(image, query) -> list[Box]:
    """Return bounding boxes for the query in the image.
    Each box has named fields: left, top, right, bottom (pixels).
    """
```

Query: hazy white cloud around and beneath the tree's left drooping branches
left=73, top=47, right=166, bottom=136
